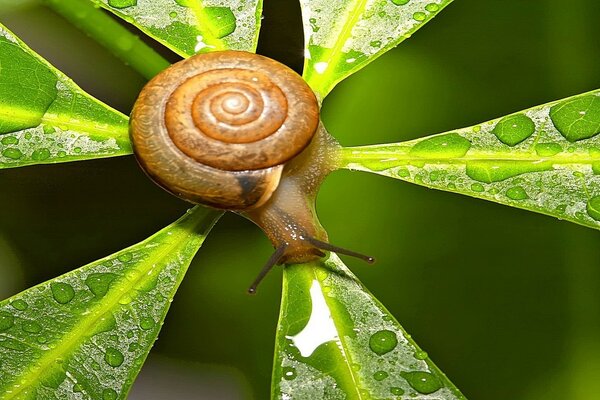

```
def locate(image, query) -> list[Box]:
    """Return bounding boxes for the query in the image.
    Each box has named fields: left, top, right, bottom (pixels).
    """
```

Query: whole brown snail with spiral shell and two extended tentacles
left=130, top=51, right=373, bottom=293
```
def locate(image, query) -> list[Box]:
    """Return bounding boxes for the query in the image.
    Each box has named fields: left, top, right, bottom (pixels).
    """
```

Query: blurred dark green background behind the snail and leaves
left=0, top=0, right=600, bottom=400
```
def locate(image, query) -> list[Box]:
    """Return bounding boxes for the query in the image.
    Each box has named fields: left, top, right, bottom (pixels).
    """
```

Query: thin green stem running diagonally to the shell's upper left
left=43, top=0, right=170, bottom=79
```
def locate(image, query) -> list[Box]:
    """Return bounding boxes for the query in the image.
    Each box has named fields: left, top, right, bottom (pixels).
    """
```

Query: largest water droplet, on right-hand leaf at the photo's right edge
left=550, top=94, right=600, bottom=142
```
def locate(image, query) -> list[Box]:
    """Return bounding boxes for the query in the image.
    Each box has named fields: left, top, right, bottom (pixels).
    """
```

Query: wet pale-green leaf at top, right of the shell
left=300, top=0, right=452, bottom=98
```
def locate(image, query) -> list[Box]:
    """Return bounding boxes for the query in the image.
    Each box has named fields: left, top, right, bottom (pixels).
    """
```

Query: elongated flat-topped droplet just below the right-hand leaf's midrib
left=467, top=160, right=552, bottom=183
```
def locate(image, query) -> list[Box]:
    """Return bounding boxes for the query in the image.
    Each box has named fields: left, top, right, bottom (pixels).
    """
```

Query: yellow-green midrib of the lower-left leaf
left=2, top=229, right=198, bottom=400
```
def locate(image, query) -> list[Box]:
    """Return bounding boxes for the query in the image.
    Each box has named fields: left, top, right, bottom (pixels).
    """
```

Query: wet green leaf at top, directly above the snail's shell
left=93, top=0, right=262, bottom=57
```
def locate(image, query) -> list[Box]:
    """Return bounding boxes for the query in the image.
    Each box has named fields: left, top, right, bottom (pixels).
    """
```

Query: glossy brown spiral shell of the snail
left=130, top=51, right=319, bottom=210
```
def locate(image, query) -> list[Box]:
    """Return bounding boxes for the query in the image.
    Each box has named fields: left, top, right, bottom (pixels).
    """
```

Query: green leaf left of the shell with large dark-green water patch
left=0, top=25, right=131, bottom=169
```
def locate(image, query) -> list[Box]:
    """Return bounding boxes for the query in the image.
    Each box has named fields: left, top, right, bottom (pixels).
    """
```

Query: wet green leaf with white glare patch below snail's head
left=272, top=254, right=464, bottom=400
